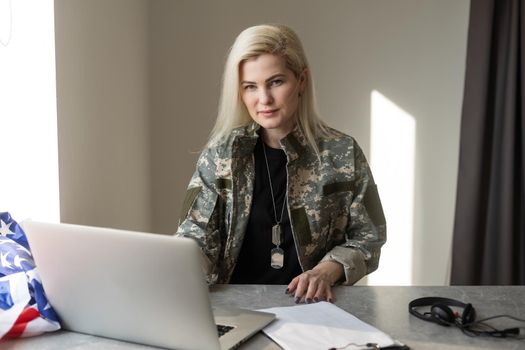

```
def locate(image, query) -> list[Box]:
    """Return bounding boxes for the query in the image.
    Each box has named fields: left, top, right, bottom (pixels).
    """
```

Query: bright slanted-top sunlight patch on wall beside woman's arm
left=368, top=90, right=416, bottom=285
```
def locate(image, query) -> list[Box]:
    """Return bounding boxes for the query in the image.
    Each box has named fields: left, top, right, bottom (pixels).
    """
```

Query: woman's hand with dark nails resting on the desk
left=286, top=261, right=344, bottom=303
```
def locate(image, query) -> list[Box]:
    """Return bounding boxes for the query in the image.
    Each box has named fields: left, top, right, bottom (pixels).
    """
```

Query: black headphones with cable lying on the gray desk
left=408, top=297, right=525, bottom=339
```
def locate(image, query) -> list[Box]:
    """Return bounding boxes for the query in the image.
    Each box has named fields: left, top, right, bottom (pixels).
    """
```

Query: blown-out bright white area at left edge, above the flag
left=0, top=0, right=60, bottom=222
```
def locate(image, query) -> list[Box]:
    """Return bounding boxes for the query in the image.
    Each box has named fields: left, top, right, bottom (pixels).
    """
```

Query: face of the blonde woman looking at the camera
left=240, top=54, right=306, bottom=136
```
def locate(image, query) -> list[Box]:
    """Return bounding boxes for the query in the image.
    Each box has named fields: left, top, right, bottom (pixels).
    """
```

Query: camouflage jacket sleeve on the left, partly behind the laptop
left=176, top=148, right=221, bottom=284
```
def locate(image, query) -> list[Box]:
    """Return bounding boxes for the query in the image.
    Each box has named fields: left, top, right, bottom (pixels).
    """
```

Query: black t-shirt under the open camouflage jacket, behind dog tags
left=230, top=137, right=302, bottom=284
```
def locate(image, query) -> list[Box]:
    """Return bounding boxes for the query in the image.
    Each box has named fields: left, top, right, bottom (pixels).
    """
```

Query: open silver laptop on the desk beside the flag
left=22, top=221, right=275, bottom=350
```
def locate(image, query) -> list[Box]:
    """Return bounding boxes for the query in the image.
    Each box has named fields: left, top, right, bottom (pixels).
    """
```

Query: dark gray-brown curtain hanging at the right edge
left=451, top=0, right=525, bottom=285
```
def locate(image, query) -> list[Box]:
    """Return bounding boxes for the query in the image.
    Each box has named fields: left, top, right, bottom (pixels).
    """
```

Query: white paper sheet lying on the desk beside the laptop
left=260, top=302, right=395, bottom=350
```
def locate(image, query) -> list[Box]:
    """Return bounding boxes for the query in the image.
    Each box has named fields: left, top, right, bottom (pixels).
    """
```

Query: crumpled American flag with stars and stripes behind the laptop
left=0, top=212, right=60, bottom=340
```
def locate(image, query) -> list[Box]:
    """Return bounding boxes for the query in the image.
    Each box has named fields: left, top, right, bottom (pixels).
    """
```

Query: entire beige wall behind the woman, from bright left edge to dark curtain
left=56, top=0, right=469, bottom=285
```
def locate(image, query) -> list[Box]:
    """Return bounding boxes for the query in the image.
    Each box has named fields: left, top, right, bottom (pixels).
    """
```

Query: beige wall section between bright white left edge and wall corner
left=55, top=0, right=151, bottom=230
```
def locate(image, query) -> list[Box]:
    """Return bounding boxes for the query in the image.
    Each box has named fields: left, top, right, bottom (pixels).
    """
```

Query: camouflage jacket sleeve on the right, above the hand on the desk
left=321, top=141, right=386, bottom=285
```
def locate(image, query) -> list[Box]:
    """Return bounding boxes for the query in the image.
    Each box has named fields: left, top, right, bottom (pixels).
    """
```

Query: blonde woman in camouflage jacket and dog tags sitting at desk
left=177, top=25, right=386, bottom=303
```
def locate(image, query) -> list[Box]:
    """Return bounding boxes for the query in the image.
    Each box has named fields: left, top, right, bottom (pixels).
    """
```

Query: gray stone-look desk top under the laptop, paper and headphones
left=0, top=285, right=525, bottom=350
